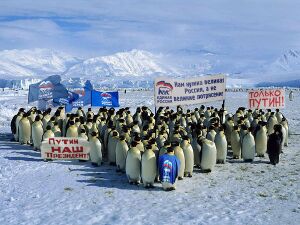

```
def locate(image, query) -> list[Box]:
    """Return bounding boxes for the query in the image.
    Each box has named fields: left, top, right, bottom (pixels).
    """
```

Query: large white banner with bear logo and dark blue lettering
left=154, top=74, right=226, bottom=106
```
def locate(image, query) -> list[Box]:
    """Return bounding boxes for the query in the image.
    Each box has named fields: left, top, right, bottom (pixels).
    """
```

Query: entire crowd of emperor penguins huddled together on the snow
left=11, top=105, right=289, bottom=190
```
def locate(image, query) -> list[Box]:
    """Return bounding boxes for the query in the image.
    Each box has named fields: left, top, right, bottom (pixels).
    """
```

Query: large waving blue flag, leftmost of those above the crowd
left=28, top=75, right=68, bottom=103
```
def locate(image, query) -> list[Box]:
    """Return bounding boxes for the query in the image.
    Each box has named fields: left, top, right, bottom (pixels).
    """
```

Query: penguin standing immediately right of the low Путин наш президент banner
left=89, top=131, right=102, bottom=166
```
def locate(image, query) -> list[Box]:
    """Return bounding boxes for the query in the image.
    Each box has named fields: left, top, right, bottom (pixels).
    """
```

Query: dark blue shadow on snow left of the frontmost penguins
left=71, top=162, right=162, bottom=191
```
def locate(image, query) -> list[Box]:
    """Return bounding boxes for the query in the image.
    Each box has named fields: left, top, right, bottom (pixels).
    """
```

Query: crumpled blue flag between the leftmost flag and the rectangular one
left=66, top=80, right=93, bottom=112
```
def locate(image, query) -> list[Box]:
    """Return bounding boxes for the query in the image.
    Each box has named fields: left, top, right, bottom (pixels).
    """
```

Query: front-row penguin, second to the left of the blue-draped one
left=126, top=141, right=141, bottom=184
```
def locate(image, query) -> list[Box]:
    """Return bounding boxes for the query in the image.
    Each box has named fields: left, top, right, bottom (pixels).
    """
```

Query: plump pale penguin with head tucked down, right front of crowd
left=199, top=138, right=217, bottom=172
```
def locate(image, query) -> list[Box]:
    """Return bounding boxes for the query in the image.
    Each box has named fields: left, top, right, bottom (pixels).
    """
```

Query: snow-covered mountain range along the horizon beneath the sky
left=0, top=49, right=300, bottom=88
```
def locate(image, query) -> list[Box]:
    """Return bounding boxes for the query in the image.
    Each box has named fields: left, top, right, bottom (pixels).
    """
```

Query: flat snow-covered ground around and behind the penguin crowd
left=0, top=91, right=300, bottom=225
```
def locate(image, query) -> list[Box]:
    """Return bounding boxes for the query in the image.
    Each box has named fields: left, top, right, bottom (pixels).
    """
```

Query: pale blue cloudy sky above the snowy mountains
left=0, top=0, right=300, bottom=60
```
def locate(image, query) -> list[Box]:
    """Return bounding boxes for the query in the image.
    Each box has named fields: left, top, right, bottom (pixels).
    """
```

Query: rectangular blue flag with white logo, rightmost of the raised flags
left=92, top=90, right=120, bottom=107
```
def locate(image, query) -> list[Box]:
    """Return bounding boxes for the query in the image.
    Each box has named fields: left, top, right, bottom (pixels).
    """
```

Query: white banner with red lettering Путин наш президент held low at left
left=41, top=137, right=90, bottom=160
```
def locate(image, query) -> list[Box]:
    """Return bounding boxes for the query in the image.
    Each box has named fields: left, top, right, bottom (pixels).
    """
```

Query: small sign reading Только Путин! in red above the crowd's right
left=248, top=89, right=285, bottom=109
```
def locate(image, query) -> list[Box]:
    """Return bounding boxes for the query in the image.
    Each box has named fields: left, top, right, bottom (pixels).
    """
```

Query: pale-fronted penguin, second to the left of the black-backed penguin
left=242, top=128, right=255, bottom=162
